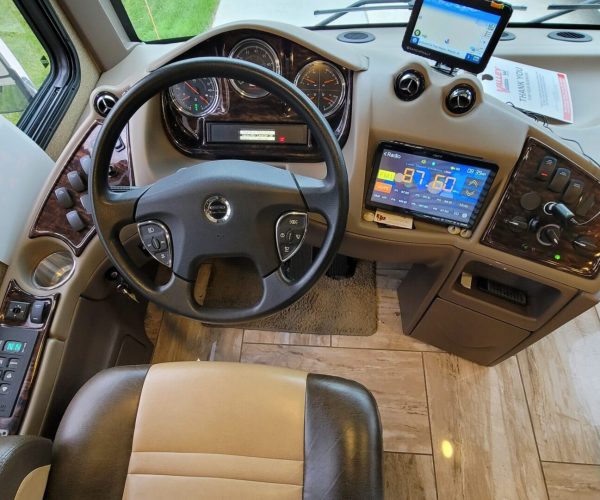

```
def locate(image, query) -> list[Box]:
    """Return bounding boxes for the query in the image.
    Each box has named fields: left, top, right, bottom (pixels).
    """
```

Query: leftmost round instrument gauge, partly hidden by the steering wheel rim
left=169, top=78, right=219, bottom=117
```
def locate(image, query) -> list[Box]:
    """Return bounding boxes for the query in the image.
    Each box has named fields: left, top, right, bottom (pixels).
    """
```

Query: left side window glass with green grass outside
left=0, top=0, right=51, bottom=124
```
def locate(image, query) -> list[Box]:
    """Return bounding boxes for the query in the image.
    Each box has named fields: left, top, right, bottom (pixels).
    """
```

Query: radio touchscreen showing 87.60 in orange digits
left=366, top=142, right=498, bottom=228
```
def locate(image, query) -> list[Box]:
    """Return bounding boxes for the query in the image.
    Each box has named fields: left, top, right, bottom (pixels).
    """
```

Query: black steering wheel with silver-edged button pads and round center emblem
left=89, top=57, right=348, bottom=324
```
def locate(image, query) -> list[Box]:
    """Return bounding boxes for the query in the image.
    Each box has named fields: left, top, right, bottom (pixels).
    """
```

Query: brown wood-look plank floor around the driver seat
left=147, top=270, right=600, bottom=500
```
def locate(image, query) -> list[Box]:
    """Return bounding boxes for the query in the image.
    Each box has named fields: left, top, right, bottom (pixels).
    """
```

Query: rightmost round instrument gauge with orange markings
left=294, top=61, right=346, bottom=116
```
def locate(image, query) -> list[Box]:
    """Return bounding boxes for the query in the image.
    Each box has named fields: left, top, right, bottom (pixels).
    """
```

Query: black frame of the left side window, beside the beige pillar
left=15, top=0, right=81, bottom=148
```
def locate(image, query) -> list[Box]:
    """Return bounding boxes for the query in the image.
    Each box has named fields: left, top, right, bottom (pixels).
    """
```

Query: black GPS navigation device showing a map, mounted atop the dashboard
left=402, top=0, right=512, bottom=73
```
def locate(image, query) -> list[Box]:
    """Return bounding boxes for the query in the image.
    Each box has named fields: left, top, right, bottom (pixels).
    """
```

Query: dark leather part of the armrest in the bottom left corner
left=0, top=436, right=52, bottom=500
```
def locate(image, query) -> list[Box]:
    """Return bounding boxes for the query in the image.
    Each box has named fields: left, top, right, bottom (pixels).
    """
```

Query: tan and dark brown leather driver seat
left=1, top=362, right=383, bottom=500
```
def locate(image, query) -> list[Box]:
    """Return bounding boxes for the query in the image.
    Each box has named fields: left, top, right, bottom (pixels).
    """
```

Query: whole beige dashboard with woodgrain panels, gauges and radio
left=4, top=22, right=600, bottom=386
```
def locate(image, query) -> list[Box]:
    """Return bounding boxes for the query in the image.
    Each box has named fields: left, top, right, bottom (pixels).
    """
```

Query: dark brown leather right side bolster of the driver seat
left=303, top=374, right=383, bottom=500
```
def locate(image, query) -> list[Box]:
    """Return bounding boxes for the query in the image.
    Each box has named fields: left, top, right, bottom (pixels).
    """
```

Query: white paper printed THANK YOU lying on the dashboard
left=479, top=57, right=573, bottom=123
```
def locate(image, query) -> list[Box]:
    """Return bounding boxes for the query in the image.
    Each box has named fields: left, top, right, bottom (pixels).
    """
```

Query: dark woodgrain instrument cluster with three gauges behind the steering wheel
left=162, top=30, right=352, bottom=161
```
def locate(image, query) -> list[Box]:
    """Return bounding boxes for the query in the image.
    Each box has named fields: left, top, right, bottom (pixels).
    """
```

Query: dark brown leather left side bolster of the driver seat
left=45, top=366, right=149, bottom=500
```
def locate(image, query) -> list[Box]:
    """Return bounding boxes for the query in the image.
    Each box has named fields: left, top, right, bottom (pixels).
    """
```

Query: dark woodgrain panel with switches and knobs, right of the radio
left=481, top=138, right=600, bottom=278
